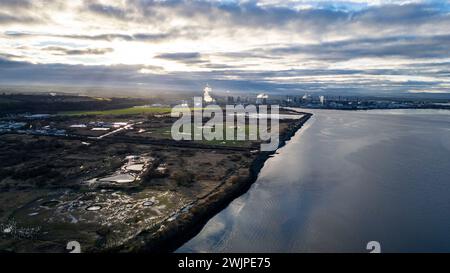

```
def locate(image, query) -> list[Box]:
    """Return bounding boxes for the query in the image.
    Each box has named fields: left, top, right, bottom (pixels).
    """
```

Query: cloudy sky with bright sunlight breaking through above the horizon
left=0, top=0, right=450, bottom=95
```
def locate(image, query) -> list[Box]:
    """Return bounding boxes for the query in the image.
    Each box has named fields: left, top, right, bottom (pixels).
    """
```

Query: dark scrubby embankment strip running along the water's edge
left=113, top=109, right=313, bottom=252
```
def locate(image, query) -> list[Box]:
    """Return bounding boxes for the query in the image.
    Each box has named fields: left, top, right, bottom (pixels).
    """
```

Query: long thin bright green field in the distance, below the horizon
left=59, top=107, right=171, bottom=116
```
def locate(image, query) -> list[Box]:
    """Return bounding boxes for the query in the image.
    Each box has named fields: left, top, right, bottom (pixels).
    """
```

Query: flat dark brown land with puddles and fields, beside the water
left=0, top=95, right=311, bottom=252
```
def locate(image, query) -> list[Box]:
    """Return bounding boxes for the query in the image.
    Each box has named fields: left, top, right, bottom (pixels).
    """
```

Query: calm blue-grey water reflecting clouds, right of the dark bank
left=178, top=110, right=450, bottom=252
